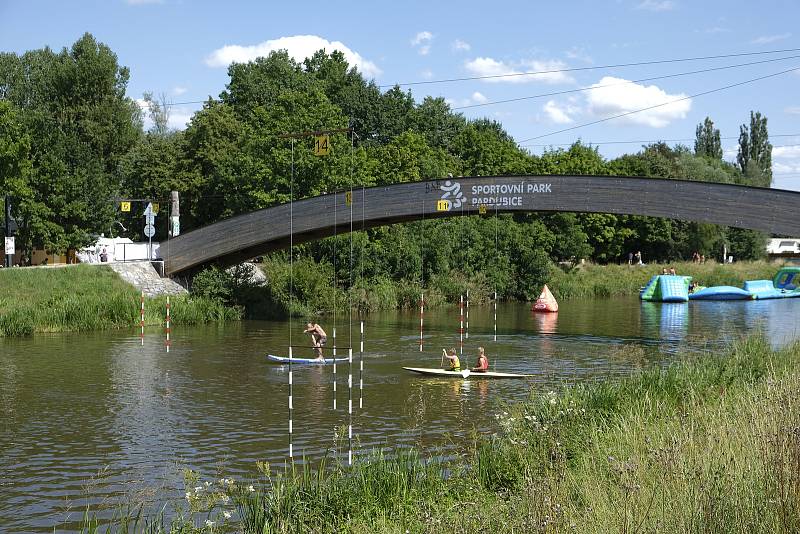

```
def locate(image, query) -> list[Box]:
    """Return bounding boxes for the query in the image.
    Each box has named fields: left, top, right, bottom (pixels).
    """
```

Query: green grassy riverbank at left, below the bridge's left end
left=0, top=265, right=241, bottom=337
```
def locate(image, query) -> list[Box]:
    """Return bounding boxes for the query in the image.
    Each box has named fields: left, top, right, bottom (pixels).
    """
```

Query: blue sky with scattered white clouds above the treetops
left=0, top=0, right=800, bottom=191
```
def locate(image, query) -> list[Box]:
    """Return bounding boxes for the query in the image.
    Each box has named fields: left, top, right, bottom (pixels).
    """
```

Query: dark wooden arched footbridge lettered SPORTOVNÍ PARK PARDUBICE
left=161, top=176, right=800, bottom=275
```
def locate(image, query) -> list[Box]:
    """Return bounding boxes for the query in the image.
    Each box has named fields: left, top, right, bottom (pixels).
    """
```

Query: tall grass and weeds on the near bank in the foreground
left=75, top=336, right=800, bottom=533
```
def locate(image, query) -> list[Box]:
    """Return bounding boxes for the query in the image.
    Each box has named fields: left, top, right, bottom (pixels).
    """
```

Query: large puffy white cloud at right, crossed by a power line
left=586, top=76, right=692, bottom=128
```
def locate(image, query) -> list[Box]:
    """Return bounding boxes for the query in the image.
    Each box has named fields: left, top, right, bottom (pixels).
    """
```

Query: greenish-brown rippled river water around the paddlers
left=0, top=298, right=800, bottom=532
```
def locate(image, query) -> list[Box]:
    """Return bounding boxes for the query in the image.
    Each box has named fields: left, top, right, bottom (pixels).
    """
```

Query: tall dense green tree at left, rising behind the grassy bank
left=0, top=33, right=141, bottom=258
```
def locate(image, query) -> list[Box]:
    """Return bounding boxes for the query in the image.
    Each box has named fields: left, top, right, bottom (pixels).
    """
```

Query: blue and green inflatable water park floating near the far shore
left=639, top=267, right=800, bottom=302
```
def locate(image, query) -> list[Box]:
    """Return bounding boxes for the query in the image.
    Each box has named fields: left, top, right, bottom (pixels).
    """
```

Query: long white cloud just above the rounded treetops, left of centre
left=206, top=35, right=381, bottom=77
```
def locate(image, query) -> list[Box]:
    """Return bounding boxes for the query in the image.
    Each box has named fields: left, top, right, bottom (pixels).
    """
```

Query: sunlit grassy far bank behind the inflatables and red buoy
left=547, top=261, right=780, bottom=299
